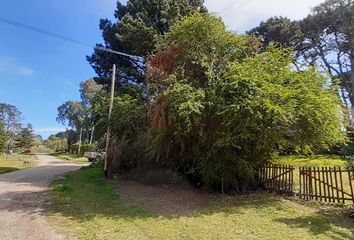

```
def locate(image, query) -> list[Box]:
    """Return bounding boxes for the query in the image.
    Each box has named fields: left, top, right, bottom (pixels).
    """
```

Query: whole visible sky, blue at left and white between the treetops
left=0, top=0, right=323, bottom=138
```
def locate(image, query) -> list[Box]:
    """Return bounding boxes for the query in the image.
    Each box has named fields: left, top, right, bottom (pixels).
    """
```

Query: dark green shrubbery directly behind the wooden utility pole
left=91, top=95, right=148, bottom=172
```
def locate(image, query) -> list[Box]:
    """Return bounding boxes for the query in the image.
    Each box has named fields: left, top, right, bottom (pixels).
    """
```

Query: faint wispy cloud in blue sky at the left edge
left=0, top=56, right=34, bottom=77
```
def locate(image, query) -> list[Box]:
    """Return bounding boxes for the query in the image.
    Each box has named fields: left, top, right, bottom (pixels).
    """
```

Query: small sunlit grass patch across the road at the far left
left=0, top=154, right=36, bottom=174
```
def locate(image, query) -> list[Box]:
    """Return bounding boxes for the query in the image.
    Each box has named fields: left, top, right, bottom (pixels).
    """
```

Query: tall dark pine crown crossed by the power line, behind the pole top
left=87, top=0, right=206, bottom=86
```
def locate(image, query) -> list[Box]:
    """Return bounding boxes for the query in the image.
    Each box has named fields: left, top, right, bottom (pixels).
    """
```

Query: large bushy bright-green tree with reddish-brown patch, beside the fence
left=147, top=14, right=345, bottom=191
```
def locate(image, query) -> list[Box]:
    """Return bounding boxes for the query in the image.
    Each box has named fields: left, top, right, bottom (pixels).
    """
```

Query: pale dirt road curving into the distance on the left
left=0, top=155, right=86, bottom=240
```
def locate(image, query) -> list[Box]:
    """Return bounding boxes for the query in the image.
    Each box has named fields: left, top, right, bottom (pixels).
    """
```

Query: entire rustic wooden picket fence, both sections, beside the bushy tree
left=258, top=167, right=354, bottom=205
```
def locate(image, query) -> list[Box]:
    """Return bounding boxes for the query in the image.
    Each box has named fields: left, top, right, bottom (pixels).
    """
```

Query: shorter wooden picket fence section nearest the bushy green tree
left=259, top=164, right=295, bottom=194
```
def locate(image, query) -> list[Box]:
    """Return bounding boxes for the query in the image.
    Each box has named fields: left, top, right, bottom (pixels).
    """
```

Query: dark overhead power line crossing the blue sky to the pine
left=0, top=17, right=137, bottom=58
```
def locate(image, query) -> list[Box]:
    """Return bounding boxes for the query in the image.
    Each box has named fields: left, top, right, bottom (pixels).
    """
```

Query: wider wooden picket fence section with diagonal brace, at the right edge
left=298, top=167, right=354, bottom=204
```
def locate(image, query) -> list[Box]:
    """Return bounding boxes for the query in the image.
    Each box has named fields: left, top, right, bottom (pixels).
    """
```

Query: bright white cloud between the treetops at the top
left=205, top=0, right=324, bottom=33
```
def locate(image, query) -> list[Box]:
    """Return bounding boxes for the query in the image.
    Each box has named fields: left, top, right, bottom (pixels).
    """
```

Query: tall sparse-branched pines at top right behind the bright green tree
left=248, top=0, right=354, bottom=125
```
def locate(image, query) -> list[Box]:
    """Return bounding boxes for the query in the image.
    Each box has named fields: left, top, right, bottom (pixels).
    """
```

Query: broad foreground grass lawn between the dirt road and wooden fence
left=47, top=166, right=354, bottom=240
